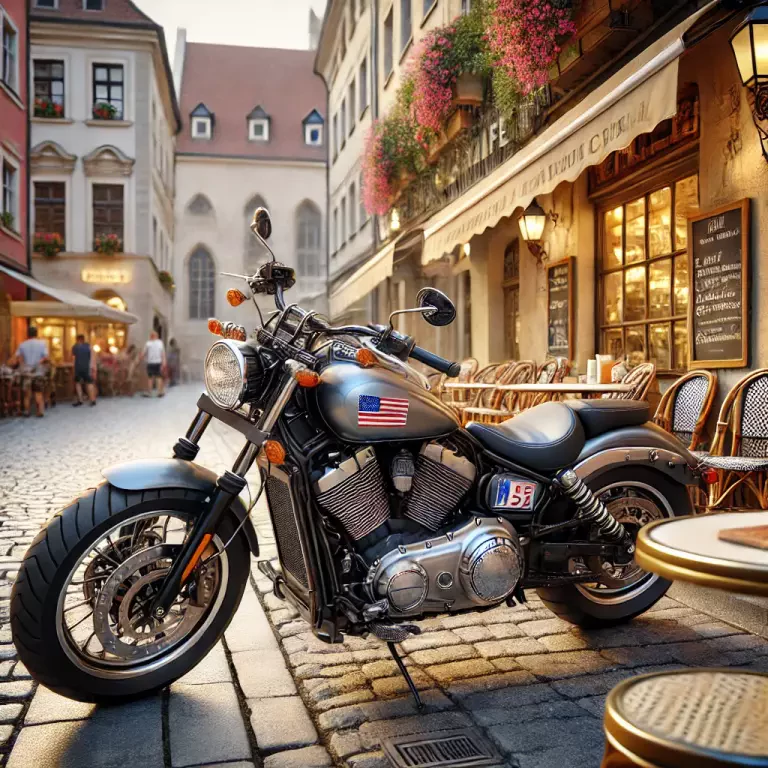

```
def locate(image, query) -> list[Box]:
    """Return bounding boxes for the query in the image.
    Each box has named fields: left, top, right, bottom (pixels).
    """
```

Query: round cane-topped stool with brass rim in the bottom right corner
left=602, top=669, right=768, bottom=768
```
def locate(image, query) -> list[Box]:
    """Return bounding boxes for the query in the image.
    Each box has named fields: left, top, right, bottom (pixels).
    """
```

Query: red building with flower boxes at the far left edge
left=0, top=0, right=29, bottom=356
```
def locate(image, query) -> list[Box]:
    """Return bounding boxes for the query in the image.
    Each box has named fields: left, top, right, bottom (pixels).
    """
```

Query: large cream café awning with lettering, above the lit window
left=422, top=2, right=716, bottom=264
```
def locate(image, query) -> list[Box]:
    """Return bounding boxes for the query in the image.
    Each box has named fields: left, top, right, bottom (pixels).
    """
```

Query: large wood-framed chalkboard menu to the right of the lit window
left=688, top=199, right=749, bottom=368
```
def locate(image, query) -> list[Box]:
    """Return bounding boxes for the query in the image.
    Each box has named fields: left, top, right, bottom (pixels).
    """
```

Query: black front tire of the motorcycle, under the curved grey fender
left=11, top=483, right=250, bottom=703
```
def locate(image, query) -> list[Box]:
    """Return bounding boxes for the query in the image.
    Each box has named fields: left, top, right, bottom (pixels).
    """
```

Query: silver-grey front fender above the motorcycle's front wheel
left=101, top=459, right=259, bottom=557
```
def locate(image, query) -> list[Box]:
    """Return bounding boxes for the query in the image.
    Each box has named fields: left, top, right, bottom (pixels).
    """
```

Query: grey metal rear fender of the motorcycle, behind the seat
left=573, top=422, right=699, bottom=485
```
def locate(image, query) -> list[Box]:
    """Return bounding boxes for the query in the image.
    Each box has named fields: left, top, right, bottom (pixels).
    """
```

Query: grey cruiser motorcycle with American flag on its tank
left=11, top=208, right=699, bottom=702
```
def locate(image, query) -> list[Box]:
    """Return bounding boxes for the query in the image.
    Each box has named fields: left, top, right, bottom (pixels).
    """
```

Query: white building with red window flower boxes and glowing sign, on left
left=25, top=0, right=180, bottom=359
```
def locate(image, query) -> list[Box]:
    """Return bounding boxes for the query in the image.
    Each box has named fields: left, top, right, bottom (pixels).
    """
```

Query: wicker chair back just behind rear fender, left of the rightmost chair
left=653, top=371, right=717, bottom=451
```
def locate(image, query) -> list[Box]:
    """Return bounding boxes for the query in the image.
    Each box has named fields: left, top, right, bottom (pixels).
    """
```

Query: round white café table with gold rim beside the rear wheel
left=635, top=511, right=768, bottom=597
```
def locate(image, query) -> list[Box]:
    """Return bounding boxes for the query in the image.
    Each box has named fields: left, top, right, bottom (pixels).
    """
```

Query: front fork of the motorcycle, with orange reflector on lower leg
left=149, top=361, right=301, bottom=619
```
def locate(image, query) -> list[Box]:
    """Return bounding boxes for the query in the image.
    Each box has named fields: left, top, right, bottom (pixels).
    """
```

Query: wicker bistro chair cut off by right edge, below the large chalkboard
left=700, top=368, right=768, bottom=511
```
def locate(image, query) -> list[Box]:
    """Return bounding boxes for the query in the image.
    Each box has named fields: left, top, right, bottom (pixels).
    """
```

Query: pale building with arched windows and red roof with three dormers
left=174, top=30, right=327, bottom=378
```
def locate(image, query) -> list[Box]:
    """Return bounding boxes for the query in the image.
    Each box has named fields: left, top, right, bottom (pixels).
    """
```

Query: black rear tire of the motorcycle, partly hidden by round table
left=536, top=467, right=694, bottom=628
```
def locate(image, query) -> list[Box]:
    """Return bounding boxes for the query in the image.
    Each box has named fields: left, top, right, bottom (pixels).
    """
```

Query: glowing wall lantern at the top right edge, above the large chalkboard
left=731, top=5, right=768, bottom=160
